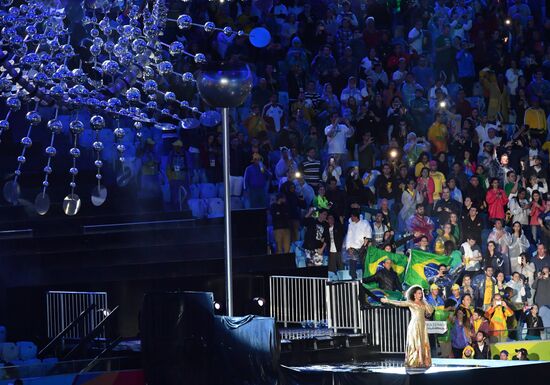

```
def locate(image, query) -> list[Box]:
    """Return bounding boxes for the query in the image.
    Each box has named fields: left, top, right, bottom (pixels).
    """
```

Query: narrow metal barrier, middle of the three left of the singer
left=326, top=281, right=364, bottom=333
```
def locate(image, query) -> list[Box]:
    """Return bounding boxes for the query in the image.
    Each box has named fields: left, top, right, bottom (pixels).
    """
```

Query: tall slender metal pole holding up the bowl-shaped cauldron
left=222, top=107, right=233, bottom=317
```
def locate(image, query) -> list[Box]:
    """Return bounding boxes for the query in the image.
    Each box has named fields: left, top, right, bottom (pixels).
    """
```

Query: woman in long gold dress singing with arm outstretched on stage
left=381, top=285, right=434, bottom=369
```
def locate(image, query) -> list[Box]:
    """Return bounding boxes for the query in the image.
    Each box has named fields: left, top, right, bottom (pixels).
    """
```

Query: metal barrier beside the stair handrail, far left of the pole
left=46, top=291, right=109, bottom=339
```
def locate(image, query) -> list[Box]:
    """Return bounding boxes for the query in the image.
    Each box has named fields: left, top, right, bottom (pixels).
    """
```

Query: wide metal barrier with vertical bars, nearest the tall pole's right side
left=269, top=276, right=328, bottom=327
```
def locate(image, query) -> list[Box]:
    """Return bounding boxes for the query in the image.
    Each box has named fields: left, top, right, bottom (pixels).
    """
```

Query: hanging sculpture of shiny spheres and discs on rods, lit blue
left=0, top=0, right=270, bottom=215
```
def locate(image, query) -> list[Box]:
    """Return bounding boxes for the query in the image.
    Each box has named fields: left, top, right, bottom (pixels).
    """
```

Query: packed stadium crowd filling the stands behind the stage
left=132, top=0, right=550, bottom=358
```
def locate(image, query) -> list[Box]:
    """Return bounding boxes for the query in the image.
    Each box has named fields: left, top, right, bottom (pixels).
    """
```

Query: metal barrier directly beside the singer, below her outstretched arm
left=363, top=307, right=411, bottom=353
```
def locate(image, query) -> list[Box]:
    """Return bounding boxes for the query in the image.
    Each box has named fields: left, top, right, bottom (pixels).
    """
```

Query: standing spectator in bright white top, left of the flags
left=344, top=210, right=372, bottom=279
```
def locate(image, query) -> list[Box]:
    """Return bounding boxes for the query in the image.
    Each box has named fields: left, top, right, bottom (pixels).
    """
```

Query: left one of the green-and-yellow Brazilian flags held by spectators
left=363, top=246, right=407, bottom=305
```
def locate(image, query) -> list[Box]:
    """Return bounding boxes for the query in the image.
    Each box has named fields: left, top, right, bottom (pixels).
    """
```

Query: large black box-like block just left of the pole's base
left=141, top=292, right=214, bottom=385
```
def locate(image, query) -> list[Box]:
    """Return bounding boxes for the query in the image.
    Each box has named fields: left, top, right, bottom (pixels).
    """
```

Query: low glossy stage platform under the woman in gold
left=282, top=358, right=550, bottom=385
